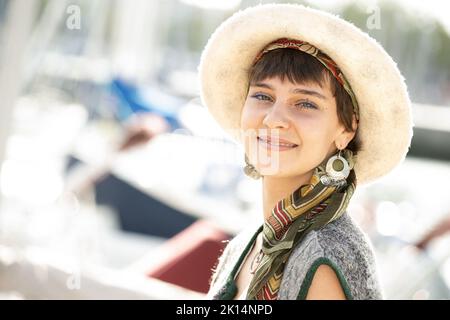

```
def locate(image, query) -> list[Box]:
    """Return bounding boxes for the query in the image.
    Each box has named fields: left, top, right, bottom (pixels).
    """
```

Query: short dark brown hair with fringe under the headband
left=248, top=48, right=361, bottom=154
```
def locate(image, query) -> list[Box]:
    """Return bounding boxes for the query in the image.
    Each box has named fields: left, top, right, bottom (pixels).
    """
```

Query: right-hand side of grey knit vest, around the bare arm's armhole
left=280, top=213, right=382, bottom=299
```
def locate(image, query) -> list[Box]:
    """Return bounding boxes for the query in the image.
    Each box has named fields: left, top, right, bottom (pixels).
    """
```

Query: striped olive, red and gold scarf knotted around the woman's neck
left=247, top=150, right=356, bottom=300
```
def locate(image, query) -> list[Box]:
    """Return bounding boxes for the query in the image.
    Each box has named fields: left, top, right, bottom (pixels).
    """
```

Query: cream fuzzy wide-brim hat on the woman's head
left=198, top=4, right=413, bottom=184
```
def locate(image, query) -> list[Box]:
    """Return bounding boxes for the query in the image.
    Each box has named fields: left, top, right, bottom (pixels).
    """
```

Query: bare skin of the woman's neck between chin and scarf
left=262, top=171, right=313, bottom=221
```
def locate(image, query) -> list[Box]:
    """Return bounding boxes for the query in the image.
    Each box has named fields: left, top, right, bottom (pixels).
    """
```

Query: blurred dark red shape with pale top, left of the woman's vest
left=147, top=220, right=230, bottom=293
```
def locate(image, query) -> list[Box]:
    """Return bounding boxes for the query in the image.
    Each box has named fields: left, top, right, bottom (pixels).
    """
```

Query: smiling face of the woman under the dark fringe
left=241, top=77, right=354, bottom=177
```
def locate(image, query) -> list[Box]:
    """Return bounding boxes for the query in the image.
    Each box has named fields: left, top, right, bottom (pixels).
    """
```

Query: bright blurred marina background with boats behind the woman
left=0, top=0, right=450, bottom=299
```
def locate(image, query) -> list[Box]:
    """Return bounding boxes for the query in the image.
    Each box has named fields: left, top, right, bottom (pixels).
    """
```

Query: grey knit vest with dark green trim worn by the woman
left=207, top=213, right=382, bottom=300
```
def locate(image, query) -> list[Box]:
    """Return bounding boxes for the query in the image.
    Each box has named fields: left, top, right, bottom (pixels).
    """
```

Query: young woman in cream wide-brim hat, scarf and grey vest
left=199, top=4, right=412, bottom=300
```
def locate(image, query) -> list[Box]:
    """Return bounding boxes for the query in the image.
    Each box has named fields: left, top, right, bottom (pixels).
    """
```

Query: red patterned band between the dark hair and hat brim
left=253, top=38, right=359, bottom=122
